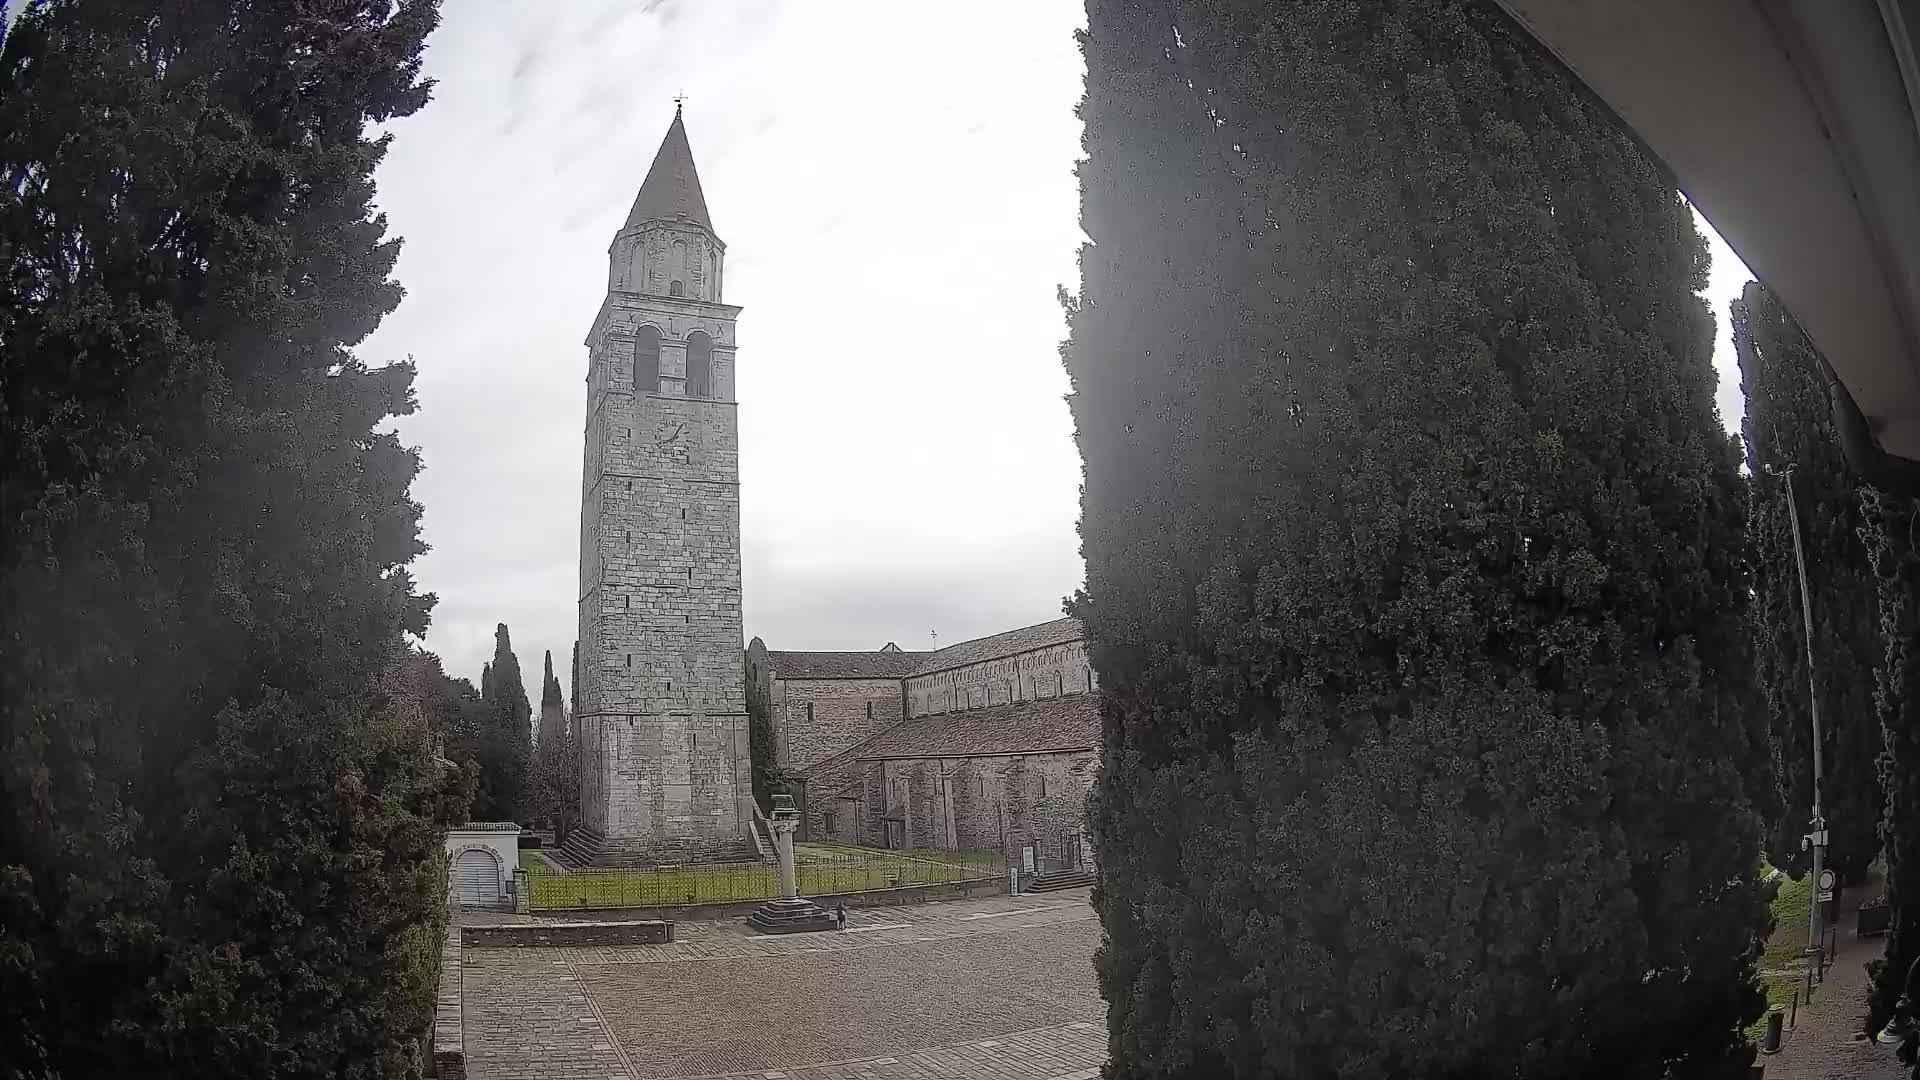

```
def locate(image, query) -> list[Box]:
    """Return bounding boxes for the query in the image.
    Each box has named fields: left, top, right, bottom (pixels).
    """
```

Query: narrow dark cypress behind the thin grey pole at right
left=1732, top=282, right=1882, bottom=882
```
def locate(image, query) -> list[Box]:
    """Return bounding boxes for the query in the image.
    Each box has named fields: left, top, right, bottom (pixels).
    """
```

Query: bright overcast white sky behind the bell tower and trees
left=361, top=0, right=1747, bottom=694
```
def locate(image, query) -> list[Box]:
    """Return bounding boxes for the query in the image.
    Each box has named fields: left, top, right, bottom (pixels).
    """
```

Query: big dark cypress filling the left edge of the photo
left=0, top=0, right=445, bottom=1078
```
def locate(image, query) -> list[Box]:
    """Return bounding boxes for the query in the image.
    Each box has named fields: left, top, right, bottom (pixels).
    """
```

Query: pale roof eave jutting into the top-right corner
left=1500, top=0, right=1920, bottom=490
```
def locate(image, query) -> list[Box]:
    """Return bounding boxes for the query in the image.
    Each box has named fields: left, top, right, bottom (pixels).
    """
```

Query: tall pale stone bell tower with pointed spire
left=568, top=110, right=753, bottom=865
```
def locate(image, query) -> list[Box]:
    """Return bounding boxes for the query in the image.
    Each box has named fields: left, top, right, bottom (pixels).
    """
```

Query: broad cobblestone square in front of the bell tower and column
left=461, top=892, right=1106, bottom=1080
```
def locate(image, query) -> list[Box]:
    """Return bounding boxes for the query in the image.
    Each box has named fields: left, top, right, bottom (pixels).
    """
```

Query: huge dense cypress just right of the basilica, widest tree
left=1064, top=0, right=1768, bottom=1078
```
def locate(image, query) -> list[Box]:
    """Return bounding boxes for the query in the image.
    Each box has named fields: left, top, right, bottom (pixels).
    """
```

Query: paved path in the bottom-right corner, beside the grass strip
left=1759, top=922, right=1907, bottom=1080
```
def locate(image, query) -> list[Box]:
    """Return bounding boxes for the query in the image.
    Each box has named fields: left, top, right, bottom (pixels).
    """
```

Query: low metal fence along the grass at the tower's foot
left=526, top=847, right=1006, bottom=911
